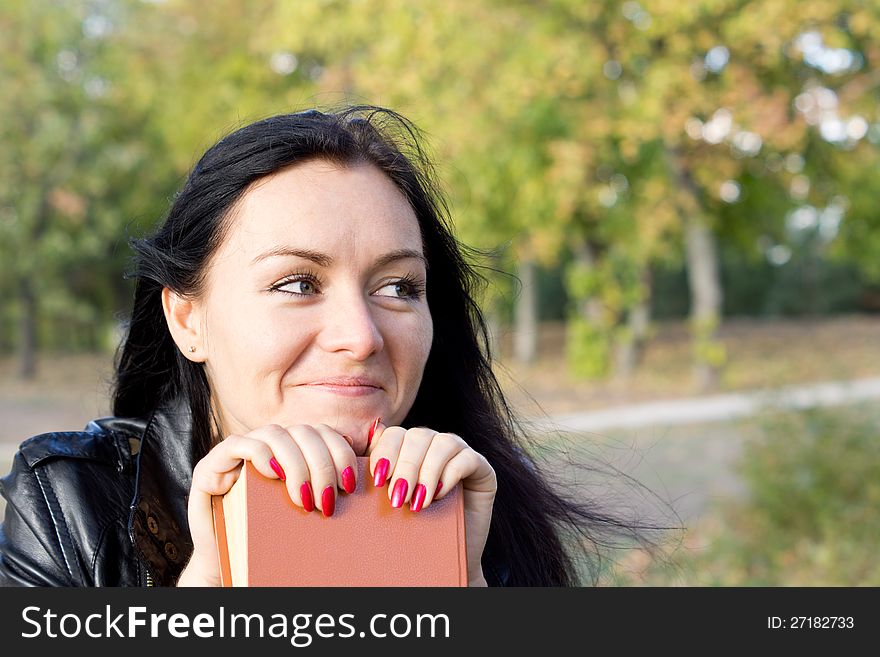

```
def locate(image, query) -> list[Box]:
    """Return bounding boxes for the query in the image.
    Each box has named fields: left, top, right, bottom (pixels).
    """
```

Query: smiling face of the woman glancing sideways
left=186, top=160, right=433, bottom=454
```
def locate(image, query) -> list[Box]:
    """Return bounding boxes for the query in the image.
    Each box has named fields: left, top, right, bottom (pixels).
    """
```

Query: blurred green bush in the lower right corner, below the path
left=618, top=406, right=880, bottom=586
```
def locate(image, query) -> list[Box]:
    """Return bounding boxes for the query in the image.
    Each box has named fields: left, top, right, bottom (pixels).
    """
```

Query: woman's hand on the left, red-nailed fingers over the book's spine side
left=177, top=424, right=357, bottom=586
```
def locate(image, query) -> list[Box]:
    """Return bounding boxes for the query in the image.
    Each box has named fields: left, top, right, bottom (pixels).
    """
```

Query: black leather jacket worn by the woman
left=0, top=406, right=507, bottom=586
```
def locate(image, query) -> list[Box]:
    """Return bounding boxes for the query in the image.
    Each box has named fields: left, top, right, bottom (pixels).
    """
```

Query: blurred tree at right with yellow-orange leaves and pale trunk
left=542, top=0, right=877, bottom=387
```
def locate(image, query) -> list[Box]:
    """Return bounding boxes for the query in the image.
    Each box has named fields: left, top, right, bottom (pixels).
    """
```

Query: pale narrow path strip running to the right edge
left=533, top=377, right=880, bottom=432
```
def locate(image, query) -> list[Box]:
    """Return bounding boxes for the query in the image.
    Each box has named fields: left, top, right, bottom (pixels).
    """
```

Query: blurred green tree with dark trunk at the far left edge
left=0, top=0, right=124, bottom=377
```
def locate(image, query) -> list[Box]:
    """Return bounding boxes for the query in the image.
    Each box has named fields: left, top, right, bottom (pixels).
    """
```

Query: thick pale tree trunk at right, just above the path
left=685, top=217, right=722, bottom=390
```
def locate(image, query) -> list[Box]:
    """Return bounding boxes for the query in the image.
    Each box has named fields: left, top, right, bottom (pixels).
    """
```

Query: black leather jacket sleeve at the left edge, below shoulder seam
left=0, top=452, right=77, bottom=586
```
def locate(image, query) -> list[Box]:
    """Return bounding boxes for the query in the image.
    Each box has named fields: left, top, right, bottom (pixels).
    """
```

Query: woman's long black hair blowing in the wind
left=113, top=106, right=664, bottom=586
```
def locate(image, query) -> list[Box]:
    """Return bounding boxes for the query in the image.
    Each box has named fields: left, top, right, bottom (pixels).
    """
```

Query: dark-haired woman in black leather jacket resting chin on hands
left=0, top=107, right=648, bottom=586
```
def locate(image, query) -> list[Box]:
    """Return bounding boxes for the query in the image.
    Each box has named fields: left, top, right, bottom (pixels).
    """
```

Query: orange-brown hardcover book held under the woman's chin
left=212, top=457, right=468, bottom=586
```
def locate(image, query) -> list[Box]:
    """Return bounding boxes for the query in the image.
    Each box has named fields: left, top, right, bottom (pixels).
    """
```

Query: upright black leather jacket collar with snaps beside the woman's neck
left=128, top=400, right=195, bottom=586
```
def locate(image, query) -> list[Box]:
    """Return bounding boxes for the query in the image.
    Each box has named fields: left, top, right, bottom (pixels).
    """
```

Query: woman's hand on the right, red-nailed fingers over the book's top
left=367, top=422, right=498, bottom=586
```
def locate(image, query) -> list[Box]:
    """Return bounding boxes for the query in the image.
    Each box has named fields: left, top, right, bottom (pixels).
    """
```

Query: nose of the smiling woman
left=319, top=295, right=385, bottom=360
